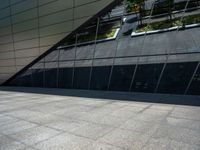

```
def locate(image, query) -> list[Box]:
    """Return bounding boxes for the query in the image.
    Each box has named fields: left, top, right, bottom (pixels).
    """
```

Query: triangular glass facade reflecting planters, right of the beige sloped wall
left=5, top=2, right=200, bottom=95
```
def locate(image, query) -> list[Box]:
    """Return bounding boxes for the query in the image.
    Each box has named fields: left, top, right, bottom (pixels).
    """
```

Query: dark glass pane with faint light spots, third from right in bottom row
left=132, top=64, right=163, bottom=92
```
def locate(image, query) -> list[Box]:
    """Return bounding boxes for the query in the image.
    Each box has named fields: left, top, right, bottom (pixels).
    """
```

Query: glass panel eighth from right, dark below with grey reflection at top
left=45, top=62, right=58, bottom=88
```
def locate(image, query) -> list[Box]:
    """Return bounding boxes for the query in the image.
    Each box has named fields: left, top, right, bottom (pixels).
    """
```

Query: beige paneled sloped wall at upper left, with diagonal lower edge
left=0, top=0, right=113, bottom=84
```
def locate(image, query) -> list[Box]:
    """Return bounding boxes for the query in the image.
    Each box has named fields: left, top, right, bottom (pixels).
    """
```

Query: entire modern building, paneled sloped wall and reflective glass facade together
left=0, top=0, right=200, bottom=95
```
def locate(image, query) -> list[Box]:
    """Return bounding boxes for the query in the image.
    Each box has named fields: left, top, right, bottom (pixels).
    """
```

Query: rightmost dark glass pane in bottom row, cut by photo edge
left=188, top=66, right=200, bottom=95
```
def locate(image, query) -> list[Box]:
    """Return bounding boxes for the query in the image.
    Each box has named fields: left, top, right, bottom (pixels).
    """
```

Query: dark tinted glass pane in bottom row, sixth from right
left=74, top=67, right=91, bottom=89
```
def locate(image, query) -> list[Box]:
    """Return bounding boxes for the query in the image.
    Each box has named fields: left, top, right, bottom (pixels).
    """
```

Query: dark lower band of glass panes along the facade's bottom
left=7, top=62, right=200, bottom=95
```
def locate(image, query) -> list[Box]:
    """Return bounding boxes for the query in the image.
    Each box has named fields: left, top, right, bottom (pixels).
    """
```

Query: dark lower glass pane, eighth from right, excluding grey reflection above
left=45, top=68, right=58, bottom=88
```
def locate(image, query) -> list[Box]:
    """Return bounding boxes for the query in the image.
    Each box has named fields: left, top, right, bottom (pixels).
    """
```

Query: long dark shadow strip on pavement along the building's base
left=0, top=87, right=200, bottom=106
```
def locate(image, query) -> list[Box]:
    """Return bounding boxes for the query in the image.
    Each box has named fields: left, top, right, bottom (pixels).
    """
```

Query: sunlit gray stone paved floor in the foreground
left=0, top=88, right=200, bottom=150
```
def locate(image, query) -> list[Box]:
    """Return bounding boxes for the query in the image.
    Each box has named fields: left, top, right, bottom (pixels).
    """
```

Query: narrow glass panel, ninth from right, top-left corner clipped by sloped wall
left=32, top=63, right=44, bottom=87
